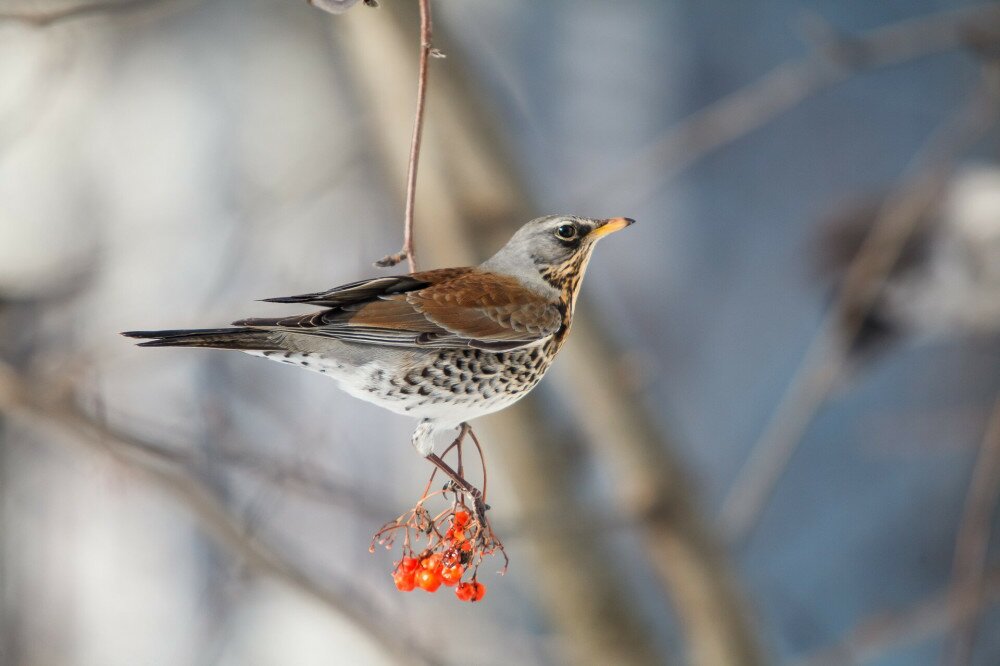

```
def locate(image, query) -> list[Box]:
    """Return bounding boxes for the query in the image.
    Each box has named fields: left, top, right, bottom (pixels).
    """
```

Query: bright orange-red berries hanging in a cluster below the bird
left=392, top=510, right=486, bottom=601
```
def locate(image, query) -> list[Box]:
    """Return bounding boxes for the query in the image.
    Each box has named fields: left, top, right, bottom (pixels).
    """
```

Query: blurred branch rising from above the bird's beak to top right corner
left=576, top=3, right=1000, bottom=201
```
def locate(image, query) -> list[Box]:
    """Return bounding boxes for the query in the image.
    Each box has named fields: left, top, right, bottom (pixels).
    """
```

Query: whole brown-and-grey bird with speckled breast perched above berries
left=123, top=215, right=633, bottom=492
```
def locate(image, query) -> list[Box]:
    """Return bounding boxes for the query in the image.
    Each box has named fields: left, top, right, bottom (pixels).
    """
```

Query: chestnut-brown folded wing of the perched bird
left=235, top=269, right=562, bottom=350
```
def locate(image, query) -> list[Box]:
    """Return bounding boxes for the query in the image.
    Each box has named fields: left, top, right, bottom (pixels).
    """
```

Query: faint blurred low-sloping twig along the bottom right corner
left=791, top=568, right=1000, bottom=666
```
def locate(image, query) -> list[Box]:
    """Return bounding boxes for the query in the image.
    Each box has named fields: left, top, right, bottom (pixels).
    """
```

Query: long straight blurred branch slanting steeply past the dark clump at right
left=719, top=80, right=997, bottom=542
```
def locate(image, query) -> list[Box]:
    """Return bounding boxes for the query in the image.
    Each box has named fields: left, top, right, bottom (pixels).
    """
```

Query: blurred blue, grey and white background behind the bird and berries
left=0, top=0, right=1000, bottom=666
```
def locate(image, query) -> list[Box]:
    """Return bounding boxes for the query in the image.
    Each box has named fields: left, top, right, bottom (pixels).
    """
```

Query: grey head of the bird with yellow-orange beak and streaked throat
left=483, top=215, right=635, bottom=292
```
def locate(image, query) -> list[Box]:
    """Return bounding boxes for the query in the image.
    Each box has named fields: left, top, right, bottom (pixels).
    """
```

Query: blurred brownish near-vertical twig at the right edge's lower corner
left=942, top=398, right=1000, bottom=666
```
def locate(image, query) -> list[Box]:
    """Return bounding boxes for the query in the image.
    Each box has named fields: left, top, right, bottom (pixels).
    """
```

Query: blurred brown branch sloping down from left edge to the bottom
left=0, top=364, right=437, bottom=663
